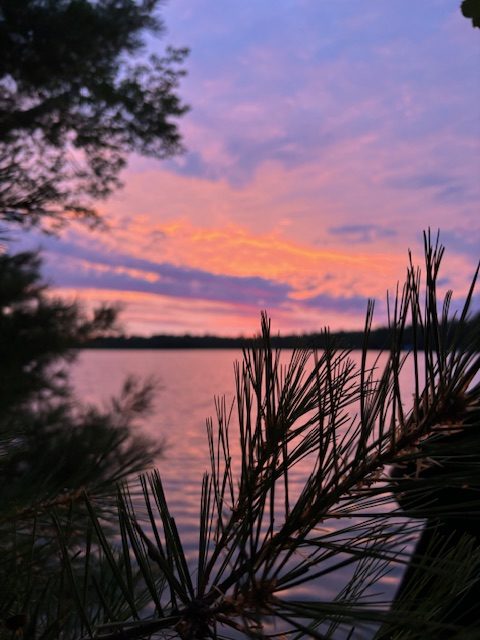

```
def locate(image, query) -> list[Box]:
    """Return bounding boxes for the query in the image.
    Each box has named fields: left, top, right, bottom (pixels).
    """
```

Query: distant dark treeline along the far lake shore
left=81, top=314, right=480, bottom=350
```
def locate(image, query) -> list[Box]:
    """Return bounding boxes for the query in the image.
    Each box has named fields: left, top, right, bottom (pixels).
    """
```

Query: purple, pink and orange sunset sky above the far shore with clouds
left=11, top=0, right=480, bottom=335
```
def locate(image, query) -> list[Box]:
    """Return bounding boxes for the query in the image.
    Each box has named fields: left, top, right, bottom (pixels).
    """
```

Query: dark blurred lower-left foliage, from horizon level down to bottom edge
left=0, top=253, right=162, bottom=638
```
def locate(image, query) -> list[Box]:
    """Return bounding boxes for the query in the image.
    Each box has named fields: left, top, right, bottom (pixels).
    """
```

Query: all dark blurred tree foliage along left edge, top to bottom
left=0, top=0, right=186, bottom=639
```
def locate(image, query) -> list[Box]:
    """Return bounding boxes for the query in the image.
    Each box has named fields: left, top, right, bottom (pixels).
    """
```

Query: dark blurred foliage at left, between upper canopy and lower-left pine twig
left=0, top=252, right=161, bottom=512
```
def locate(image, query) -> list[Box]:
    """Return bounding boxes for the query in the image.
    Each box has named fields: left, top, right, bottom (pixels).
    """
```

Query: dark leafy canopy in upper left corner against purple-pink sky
left=0, top=0, right=187, bottom=230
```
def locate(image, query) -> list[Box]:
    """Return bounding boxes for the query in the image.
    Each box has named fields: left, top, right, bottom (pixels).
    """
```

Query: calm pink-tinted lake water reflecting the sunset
left=72, top=350, right=411, bottom=632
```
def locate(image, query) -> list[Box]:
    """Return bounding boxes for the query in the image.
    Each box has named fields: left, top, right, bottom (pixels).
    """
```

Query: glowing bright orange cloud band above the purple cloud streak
left=79, top=211, right=405, bottom=299
